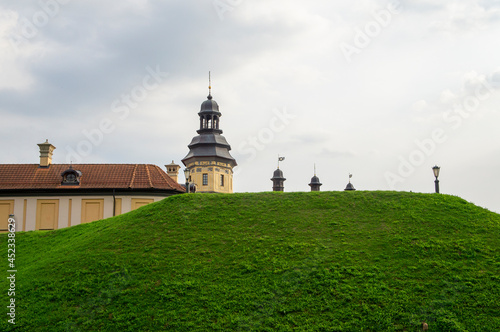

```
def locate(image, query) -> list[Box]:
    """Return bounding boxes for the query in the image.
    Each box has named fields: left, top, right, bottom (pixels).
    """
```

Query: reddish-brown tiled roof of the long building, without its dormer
left=0, top=164, right=185, bottom=192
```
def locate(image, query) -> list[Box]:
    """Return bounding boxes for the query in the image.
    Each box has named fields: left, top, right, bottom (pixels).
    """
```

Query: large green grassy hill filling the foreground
left=0, top=191, right=500, bottom=331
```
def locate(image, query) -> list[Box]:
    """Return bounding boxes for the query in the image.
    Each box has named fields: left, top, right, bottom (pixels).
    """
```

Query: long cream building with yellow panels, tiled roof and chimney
left=0, top=141, right=185, bottom=231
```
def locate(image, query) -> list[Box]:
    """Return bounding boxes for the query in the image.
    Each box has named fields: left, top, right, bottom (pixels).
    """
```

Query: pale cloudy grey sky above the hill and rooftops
left=0, top=0, right=500, bottom=212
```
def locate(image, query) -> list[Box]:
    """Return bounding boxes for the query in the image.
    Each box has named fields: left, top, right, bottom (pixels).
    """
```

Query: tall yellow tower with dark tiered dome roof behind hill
left=182, top=75, right=238, bottom=193
